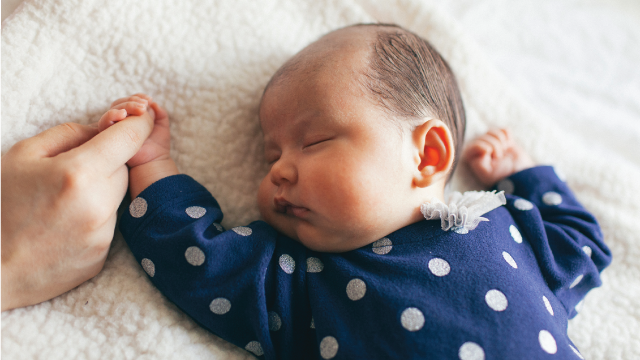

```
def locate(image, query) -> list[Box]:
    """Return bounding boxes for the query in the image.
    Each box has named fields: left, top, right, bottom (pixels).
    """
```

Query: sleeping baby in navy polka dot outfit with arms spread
left=105, top=25, right=610, bottom=360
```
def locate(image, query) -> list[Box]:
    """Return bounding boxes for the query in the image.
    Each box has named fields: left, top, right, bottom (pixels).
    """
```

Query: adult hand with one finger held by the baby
left=0, top=110, right=153, bottom=311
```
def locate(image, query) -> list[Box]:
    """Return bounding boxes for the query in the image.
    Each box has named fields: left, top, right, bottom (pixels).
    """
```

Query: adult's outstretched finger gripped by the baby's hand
left=67, top=112, right=153, bottom=176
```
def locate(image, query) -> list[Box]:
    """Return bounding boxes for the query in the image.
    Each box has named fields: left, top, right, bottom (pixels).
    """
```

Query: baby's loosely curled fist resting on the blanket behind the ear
left=463, top=129, right=535, bottom=186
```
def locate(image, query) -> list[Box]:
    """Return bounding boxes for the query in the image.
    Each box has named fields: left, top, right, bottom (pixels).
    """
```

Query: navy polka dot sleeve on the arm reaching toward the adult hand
left=119, top=175, right=311, bottom=359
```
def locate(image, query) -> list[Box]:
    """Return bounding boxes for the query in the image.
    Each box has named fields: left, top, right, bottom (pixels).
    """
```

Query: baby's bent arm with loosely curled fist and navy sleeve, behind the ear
left=464, top=130, right=611, bottom=318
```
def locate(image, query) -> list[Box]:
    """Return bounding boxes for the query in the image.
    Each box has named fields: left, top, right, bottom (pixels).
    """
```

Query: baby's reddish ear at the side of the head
left=412, top=119, right=454, bottom=187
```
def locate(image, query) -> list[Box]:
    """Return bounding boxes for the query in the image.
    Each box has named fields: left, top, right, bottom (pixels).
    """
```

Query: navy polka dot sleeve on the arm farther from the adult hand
left=497, top=166, right=611, bottom=318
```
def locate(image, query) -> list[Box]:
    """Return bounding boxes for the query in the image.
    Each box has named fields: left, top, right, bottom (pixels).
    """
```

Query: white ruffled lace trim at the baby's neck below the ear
left=420, top=191, right=507, bottom=234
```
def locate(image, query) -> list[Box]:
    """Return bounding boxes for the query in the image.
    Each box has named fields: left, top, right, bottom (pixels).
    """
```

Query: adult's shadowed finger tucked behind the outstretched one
left=19, top=123, right=98, bottom=157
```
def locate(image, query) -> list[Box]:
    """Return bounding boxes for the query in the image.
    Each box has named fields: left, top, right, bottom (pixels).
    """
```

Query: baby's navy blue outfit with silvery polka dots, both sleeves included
left=120, top=166, right=611, bottom=360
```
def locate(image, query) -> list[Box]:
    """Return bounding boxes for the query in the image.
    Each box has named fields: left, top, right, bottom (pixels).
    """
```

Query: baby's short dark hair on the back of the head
left=352, top=24, right=466, bottom=179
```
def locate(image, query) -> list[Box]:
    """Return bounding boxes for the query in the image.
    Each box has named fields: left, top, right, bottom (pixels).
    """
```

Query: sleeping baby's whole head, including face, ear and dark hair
left=258, top=25, right=465, bottom=252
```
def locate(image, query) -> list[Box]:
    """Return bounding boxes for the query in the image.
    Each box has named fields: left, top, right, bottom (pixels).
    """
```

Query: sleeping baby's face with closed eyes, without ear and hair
left=258, top=28, right=421, bottom=252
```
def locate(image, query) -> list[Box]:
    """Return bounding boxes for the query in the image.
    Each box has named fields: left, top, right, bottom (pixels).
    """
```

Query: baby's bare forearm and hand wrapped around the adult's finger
left=98, top=94, right=178, bottom=199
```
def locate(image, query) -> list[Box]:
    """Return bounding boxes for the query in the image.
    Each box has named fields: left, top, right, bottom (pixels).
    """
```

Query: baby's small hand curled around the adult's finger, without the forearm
left=98, top=94, right=171, bottom=168
